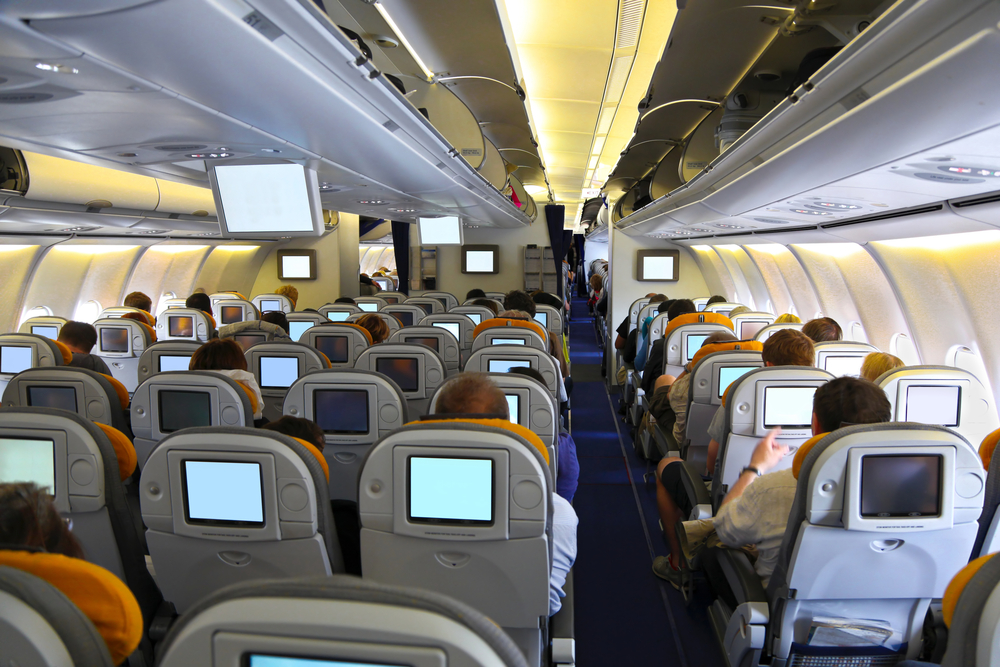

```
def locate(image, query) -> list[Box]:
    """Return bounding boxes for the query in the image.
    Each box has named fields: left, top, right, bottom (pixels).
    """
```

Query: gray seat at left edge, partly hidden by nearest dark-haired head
left=0, top=407, right=162, bottom=627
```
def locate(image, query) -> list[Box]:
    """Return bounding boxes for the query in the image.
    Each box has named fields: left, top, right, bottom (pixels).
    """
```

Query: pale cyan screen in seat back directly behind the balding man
left=410, top=456, right=493, bottom=521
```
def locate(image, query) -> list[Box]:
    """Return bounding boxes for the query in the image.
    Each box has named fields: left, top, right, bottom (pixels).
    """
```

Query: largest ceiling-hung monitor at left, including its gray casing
left=208, top=161, right=323, bottom=238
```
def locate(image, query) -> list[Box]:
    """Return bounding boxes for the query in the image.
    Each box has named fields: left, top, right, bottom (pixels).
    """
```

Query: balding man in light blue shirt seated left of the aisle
left=437, top=373, right=579, bottom=616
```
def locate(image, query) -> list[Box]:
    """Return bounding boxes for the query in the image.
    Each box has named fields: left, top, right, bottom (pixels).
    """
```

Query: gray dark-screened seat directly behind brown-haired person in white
left=131, top=371, right=257, bottom=468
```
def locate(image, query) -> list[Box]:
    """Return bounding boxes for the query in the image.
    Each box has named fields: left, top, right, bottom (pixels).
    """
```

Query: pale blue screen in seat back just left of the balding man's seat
left=184, top=461, right=264, bottom=523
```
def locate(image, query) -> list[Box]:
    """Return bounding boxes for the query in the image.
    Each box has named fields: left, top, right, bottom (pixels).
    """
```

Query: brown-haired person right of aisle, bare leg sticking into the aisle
left=653, top=329, right=816, bottom=587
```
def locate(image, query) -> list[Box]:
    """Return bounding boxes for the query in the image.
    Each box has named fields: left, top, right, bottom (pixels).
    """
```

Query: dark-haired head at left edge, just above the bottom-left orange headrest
left=0, top=482, right=83, bottom=558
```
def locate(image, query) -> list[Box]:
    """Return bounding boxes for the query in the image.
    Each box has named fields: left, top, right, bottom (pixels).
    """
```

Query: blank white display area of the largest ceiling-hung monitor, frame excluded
left=215, top=164, right=314, bottom=232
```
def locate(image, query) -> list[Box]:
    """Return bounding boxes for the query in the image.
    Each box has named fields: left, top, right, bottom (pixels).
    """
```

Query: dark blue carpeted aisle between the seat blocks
left=570, top=299, right=724, bottom=667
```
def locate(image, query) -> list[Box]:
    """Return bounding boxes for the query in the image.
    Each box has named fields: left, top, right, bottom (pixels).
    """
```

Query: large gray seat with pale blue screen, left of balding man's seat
left=139, top=426, right=344, bottom=613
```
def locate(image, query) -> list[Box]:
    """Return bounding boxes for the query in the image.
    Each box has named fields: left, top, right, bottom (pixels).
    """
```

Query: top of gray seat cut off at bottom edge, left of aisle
left=158, top=575, right=527, bottom=667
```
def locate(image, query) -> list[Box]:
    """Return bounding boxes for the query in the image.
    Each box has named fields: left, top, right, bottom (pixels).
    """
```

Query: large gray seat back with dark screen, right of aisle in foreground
left=768, top=423, right=986, bottom=664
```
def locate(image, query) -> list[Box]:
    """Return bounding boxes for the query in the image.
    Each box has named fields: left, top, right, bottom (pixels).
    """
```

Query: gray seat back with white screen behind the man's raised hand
left=712, top=366, right=833, bottom=508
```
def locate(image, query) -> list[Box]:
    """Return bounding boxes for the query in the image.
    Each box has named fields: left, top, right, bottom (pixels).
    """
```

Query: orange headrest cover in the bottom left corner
left=0, top=551, right=142, bottom=665
